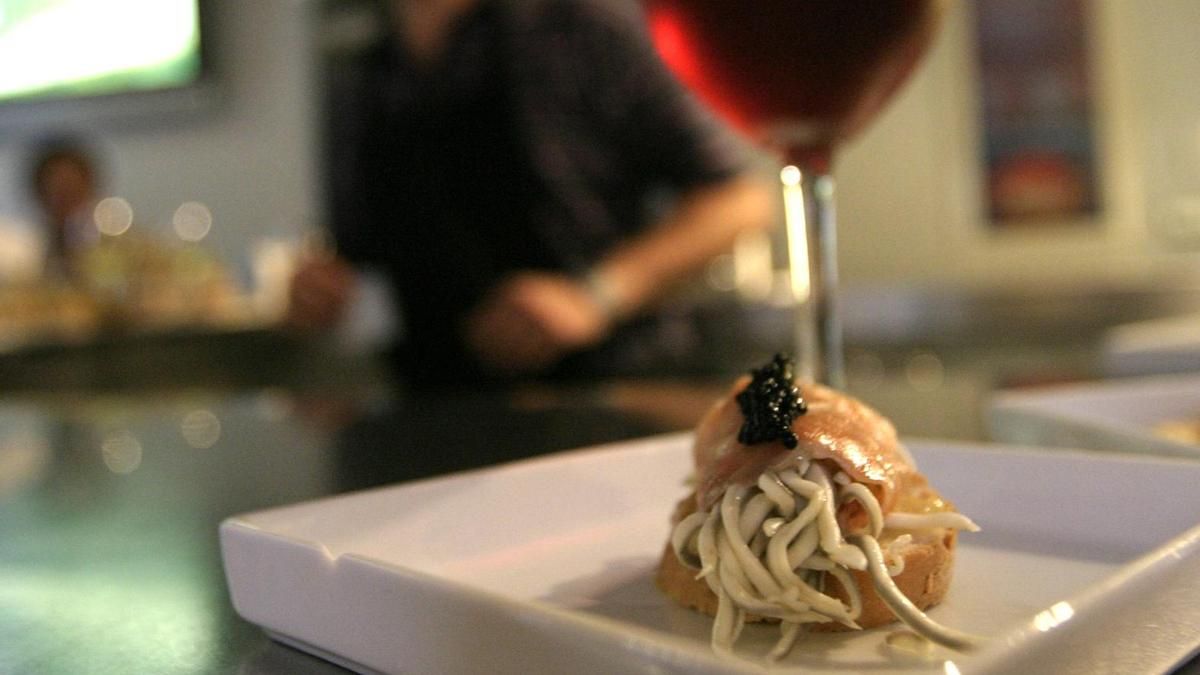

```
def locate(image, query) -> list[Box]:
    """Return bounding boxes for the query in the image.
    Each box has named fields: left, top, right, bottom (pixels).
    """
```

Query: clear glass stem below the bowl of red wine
left=780, top=167, right=846, bottom=389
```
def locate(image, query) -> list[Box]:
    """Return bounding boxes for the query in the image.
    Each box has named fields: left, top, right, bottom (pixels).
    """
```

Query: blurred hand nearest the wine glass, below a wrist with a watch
left=466, top=273, right=611, bottom=374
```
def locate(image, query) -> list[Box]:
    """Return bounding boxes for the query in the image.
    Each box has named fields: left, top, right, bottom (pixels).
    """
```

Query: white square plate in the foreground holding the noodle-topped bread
left=221, top=435, right=1200, bottom=674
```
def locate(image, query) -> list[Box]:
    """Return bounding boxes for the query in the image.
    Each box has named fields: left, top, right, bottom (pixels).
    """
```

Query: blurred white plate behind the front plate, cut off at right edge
left=988, top=375, right=1200, bottom=459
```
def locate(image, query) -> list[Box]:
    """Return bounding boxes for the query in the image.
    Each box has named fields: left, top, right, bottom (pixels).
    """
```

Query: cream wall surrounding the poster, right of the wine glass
left=835, top=0, right=1200, bottom=288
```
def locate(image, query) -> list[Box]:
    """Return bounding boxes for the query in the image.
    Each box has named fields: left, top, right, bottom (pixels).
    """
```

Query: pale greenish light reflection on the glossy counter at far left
left=0, top=394, right=343, bottom=673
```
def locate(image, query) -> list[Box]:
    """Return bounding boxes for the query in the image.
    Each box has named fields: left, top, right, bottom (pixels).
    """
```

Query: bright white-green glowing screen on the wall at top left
left=0, top=0, right=200, bottom=101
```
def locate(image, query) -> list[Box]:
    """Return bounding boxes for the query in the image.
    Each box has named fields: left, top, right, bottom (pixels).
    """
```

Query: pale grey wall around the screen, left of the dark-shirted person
left=0, top=0, right=320, bottom=283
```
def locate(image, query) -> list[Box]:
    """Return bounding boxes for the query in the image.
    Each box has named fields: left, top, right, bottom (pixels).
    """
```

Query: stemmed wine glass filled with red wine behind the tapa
left=647, top=0, right=944, bottom=388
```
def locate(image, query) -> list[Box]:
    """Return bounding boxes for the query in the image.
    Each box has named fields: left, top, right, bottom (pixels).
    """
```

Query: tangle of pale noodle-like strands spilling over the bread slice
left=671, top=451, right=979, bottom=661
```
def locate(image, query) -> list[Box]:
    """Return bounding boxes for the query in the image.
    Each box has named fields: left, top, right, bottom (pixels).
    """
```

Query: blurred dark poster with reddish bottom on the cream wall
left=974, top=0, right=1099, bottom=229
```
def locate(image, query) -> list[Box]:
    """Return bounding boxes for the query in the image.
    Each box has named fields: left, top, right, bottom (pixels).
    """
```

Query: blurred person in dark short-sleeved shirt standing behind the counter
left=288, top=0, right=775, bottom=384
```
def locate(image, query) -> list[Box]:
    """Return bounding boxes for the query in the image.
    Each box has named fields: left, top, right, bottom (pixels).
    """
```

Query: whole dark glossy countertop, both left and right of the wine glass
left=0, top=300, right=1195, bottom=675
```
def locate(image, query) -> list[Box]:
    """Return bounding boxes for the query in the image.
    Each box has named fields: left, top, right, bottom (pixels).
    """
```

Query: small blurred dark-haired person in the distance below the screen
left=29, top=138, right=100, bottom=281
